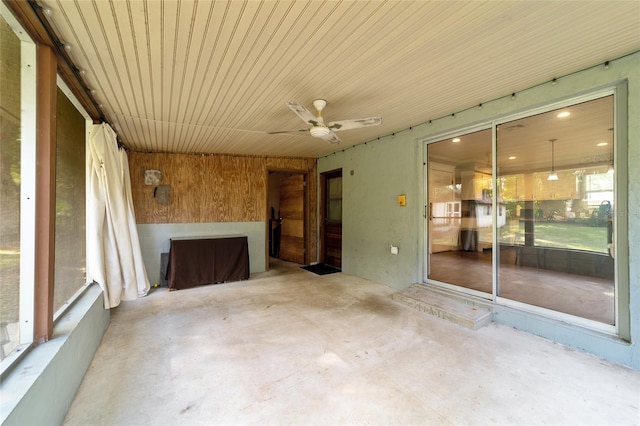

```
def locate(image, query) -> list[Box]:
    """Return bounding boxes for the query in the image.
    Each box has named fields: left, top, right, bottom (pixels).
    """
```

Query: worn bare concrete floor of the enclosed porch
left=64, top=262, right=640, bottom=425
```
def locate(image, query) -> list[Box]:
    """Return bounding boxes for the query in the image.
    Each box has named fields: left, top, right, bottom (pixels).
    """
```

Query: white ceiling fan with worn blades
left=272, top=99, right=382, bottom=144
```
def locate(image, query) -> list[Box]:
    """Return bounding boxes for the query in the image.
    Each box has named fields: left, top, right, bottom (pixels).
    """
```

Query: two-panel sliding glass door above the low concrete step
left=425, top=94, right=616, bottom=328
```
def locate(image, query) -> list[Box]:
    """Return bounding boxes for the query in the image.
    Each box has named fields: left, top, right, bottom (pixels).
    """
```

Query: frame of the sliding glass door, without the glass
left=420, top=81, right=631, bottom=341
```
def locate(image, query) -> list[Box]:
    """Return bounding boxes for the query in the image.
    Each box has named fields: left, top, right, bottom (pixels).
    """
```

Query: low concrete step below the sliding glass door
left=391, top=284, right=492, bottom=330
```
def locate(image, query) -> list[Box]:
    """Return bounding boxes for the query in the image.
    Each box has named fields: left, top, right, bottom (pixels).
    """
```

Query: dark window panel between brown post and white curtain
left=53, top=89, right=86, bottom=311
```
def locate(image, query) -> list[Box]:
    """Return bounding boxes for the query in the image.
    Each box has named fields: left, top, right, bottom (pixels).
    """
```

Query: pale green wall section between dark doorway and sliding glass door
left=321, top=137, right=422, bottom=289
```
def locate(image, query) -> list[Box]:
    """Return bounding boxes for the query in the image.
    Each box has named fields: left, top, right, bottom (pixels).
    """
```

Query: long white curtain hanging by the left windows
left=87, top=124, right=150, bottom=309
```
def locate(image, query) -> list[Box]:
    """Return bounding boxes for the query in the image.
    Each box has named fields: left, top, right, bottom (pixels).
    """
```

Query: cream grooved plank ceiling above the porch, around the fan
left=39, top=0, right=640, bottom=157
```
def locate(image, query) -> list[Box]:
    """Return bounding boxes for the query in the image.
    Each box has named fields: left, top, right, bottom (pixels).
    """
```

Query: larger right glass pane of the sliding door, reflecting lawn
left=497, top=96, right=615, bottom=324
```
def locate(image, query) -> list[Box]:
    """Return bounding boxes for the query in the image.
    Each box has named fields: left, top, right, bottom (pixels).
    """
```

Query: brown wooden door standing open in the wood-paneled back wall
left=280, top=174, right=305, bottom=264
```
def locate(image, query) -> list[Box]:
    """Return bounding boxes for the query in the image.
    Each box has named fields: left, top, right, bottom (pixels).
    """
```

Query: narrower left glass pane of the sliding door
left=427, top=129, right=492, bottom=293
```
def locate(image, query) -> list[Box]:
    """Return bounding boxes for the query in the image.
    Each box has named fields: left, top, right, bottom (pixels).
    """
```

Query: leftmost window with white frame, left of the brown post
left=0, top=8, right=36, bottom=362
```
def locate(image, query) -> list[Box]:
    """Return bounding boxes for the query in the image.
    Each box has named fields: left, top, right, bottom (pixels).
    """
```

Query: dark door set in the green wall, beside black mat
left=320, top=170, right=342, bottom=269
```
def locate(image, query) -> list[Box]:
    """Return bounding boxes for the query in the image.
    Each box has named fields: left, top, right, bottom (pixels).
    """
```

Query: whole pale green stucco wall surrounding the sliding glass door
left=318, top=52, right=640, bottom=369
